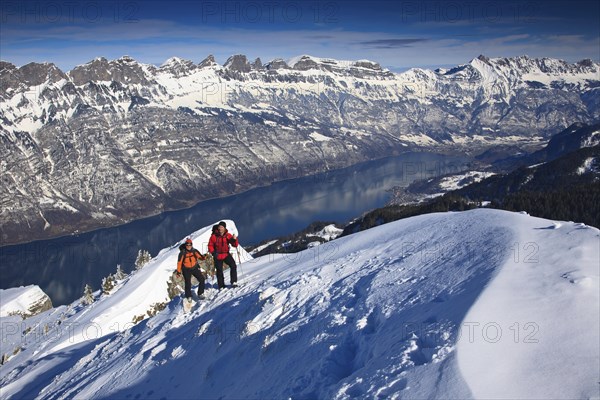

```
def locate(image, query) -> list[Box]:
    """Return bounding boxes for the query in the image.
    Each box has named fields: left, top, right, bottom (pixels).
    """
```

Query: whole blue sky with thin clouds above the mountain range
left=0, top=0, right=600, bottom=71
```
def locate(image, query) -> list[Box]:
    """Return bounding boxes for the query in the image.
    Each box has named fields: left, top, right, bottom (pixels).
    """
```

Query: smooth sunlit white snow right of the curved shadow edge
left=457, top=218, right=600, bottom=399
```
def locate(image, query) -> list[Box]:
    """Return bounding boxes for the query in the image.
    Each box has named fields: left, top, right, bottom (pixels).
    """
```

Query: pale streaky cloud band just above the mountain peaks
left=0, top=20, right=600, bottom=71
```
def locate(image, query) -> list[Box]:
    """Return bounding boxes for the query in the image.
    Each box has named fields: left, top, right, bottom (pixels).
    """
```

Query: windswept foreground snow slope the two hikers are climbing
left=0, top=210, right=600, bottom=399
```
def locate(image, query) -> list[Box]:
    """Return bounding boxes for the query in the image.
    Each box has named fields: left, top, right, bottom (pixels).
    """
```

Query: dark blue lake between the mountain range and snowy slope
left=0, top=153, right=467, bottom=306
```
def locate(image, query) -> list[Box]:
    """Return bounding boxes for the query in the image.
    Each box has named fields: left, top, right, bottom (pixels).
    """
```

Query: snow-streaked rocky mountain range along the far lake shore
left=0, top=55, right=600, bottom=245
